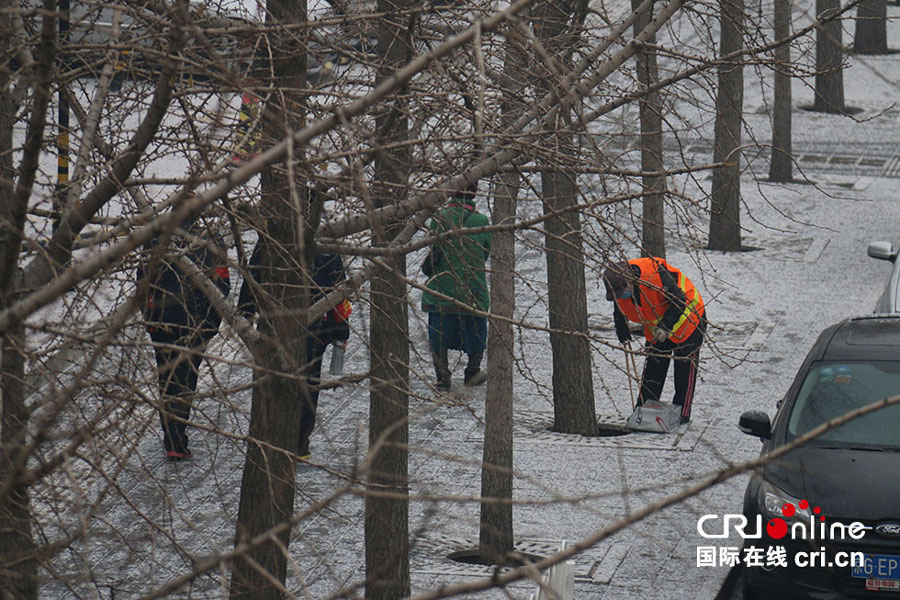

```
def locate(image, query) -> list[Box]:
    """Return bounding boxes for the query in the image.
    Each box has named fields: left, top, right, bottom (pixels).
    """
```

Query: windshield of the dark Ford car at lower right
left=788, top=361, right=900, bottom=450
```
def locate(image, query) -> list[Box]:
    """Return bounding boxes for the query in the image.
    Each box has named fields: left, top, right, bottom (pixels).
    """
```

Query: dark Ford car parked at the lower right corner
left=740, top=315, right=900, bottom=599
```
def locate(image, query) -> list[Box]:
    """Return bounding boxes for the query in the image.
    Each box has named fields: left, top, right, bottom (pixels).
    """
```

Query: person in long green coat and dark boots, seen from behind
left=422, top=184, right=491, bottom=390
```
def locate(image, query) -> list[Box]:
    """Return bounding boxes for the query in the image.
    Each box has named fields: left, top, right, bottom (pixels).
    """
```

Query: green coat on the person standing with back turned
left=422, top=202, right=491, bottom=314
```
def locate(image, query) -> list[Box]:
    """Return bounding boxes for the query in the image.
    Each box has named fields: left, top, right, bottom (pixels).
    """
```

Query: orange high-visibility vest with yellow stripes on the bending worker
left=616, top=256, right=703, bottom=344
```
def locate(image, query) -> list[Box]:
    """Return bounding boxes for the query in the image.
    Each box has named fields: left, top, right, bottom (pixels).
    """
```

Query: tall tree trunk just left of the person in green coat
left=365, top=0, right=413, bottom=600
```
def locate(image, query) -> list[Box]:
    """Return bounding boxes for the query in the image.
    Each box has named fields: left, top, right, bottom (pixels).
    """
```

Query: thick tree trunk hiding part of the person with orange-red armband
left=230, top=0, right=311, bottom=599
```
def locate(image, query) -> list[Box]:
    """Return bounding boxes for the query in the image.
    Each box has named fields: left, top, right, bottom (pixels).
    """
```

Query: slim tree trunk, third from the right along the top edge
left=769, top=0, right=794, bottom=183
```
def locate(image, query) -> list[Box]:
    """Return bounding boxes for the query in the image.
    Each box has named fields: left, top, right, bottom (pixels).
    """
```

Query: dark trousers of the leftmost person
left=148, top=323, right=218, bottom=453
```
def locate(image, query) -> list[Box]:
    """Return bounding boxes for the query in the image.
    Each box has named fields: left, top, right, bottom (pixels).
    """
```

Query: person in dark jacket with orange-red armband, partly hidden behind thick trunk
left=238, top=243, right=351, bottom=460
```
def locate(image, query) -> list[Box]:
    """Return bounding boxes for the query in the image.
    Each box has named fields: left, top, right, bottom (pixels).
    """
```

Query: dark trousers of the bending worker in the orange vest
left=638, top=315, right=706, bottom=419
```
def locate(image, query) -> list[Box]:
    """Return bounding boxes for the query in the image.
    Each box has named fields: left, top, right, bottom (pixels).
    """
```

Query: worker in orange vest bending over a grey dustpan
left=603, top=256, right=706, bottom=423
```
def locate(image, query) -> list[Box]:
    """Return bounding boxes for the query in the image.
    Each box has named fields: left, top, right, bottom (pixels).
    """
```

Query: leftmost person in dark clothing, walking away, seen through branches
left=137, top=224, right=231, bottom=461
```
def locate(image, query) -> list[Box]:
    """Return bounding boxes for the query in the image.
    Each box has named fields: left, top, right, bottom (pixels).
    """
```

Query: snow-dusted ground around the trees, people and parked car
left=22, top=1, right=900, bottom=600
